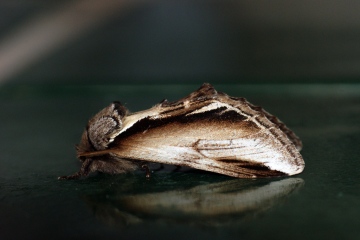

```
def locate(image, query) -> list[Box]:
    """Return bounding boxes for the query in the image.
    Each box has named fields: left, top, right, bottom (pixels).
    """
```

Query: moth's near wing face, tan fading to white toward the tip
left=86, top=117, right=303, bottom=178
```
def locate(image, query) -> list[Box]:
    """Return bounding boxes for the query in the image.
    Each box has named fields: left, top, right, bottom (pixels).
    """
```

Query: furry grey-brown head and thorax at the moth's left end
left=77, top=102, right=127, bottom=154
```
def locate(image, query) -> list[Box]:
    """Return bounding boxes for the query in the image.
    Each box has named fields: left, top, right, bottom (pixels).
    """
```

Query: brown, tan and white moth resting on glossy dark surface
left=59, top=83, right=305, bottom=179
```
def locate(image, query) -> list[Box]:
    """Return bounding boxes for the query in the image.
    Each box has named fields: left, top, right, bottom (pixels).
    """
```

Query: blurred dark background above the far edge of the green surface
left=0, top=0, right=360, bottom=86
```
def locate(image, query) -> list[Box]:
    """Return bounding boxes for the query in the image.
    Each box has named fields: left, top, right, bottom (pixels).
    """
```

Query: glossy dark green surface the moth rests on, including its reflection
left=0, top=84, right=360, bottom=239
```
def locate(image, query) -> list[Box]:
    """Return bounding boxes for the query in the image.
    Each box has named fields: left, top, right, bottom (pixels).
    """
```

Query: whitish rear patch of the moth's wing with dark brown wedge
left=196, top=136, right=304, bottom=177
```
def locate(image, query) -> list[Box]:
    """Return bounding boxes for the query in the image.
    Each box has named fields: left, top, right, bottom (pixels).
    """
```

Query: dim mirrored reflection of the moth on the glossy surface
left=85, top=175, right=303, bottom=226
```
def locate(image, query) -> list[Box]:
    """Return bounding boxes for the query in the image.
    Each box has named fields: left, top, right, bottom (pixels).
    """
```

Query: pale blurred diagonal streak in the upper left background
left=0, top=0, right=140, bottom=84
